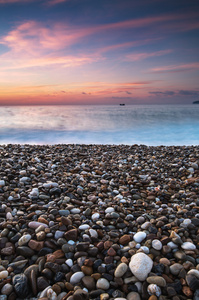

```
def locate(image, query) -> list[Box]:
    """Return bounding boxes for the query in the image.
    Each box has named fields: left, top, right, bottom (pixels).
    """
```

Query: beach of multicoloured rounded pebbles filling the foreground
left=0, top=145, right=199, bottom=300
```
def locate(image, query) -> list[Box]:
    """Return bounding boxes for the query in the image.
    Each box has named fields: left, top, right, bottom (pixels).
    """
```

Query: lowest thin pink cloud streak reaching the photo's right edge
left=151, top=62, right=199, bottom=73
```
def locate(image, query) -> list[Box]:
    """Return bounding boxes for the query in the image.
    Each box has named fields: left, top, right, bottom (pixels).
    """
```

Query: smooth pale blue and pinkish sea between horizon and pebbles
left=0, top=105, right=199, bottom=146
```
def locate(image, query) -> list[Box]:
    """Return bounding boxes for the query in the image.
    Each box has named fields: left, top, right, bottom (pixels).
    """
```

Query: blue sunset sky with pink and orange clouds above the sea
left=0, top=0, right=199, bottom=105
